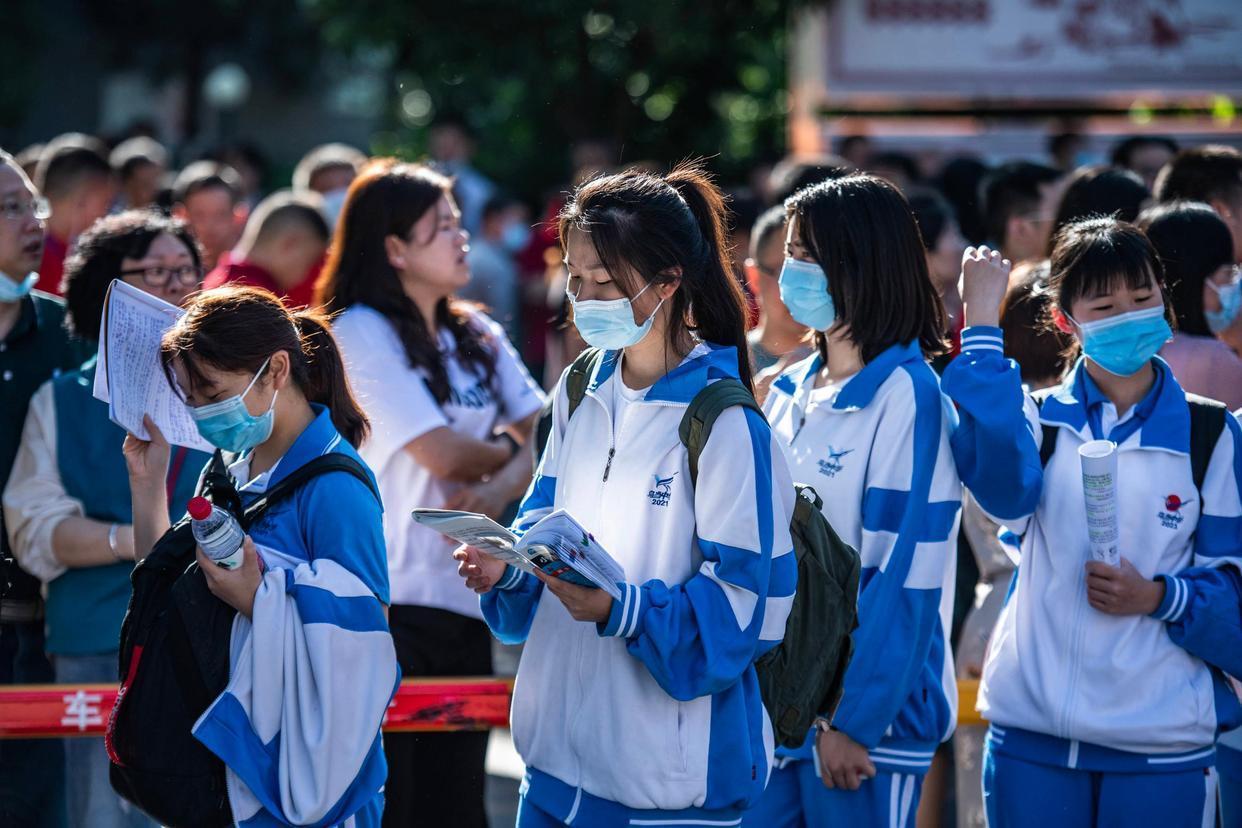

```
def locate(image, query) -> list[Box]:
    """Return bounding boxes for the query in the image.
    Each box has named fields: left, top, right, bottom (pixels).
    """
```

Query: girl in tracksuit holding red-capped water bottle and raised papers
left=124, top=288, right=389, bottom=828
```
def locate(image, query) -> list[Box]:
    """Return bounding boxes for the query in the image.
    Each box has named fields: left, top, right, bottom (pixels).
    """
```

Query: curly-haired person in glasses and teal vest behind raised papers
left=4, top=210, right=209, bottom=828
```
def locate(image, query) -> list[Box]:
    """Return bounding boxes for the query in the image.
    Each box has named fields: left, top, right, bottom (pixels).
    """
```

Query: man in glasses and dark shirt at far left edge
left=0, top=150, right=88, bottom=826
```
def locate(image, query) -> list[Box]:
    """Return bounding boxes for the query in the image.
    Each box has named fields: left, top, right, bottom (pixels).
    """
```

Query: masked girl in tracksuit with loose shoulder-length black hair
left=745, top=175, right=961, bottom=828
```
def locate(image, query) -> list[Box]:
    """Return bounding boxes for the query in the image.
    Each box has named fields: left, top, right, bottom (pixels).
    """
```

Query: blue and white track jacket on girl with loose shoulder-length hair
left=765, top=343, right=961, bottom=773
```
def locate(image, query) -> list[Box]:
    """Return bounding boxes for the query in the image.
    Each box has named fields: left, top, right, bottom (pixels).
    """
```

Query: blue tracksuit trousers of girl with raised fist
left=984, top=744, right=1216, bottom=828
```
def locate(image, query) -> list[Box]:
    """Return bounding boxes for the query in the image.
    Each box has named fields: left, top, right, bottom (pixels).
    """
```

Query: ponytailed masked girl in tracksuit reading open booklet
left=458, top=166, right=797, bottom=828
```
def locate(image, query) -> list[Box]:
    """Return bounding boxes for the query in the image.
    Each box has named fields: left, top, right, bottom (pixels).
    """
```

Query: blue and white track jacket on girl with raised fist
left=944, top=328, right=1242, bottom=772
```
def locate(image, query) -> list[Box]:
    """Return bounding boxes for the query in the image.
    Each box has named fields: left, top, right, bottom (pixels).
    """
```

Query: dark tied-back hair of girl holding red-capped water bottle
left=160, top=287, right=370, bottom=448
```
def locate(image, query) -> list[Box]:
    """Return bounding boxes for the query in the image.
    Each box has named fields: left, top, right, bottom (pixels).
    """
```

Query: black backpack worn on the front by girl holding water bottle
left=104, top=452, right=379, bottom=828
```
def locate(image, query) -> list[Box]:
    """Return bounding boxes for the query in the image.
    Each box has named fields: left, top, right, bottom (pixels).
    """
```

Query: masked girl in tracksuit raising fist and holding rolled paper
left=944, top=218, right=1242, bottom=828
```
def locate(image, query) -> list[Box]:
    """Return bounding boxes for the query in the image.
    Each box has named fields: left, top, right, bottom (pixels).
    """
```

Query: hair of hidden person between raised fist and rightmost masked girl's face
left=1001, top=262, right=1074, bottom=384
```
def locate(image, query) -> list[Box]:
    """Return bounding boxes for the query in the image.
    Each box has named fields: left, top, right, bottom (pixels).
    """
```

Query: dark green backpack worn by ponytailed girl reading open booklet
left=565, top=349, right=862, bottom=747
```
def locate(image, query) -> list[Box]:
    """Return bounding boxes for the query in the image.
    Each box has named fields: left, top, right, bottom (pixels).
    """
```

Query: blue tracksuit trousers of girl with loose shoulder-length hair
left=741, top=760, right=923, bottom=828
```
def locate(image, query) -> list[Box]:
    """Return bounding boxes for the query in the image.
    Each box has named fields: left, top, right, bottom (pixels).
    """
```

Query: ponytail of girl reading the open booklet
left=664, top=161, right=753, bottom=390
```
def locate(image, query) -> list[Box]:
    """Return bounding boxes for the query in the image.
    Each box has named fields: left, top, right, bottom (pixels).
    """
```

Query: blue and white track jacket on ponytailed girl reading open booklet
left=482, top=344, right=797, bottom=824
